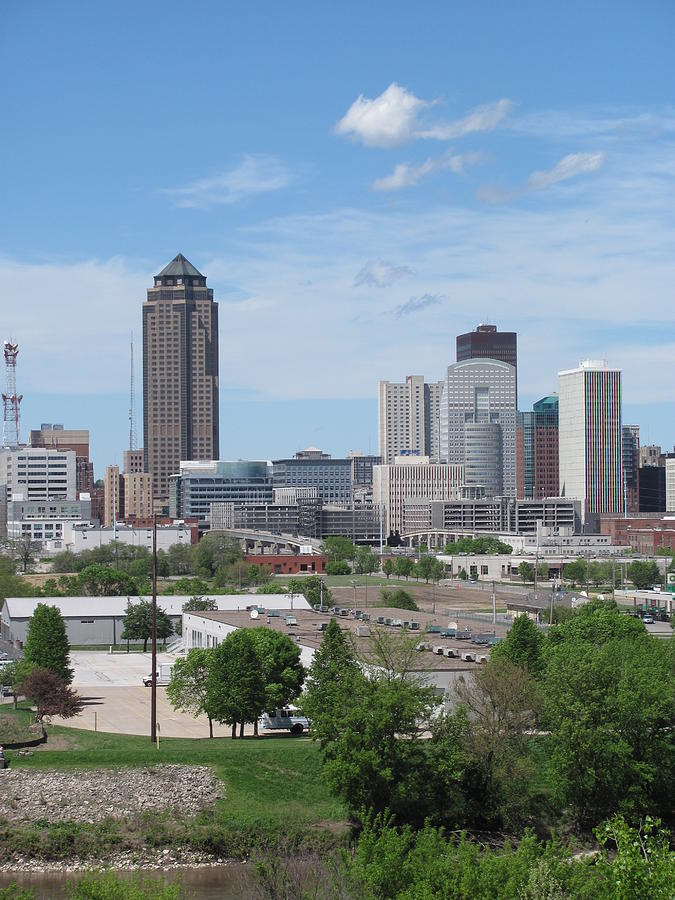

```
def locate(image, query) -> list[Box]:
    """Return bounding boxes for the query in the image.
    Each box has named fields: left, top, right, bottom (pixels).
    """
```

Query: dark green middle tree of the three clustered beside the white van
left=206, top=628, right=265, bottom=738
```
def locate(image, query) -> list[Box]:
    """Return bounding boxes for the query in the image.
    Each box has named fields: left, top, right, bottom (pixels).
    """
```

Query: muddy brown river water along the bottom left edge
left=0, top=863, right=256, bottom=900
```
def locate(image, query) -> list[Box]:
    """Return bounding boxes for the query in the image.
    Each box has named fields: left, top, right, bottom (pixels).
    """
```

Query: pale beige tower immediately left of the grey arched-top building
left=377, top=375, right=443, bottom=465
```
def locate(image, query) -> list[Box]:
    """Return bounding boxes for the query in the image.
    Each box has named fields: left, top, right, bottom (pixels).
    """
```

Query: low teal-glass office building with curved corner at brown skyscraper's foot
left=169, top=459, right=273, bottom=526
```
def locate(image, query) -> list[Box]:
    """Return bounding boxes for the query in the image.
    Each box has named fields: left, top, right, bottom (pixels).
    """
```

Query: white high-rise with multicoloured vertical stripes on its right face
left=558, top=360, right=623, bottom=523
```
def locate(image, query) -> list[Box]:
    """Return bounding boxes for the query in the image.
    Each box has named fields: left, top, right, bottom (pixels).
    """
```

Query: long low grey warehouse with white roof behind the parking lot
left=0, top=594, right=310, bottom=646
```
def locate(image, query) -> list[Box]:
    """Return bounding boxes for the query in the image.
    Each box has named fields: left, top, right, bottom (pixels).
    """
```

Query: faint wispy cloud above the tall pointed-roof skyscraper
left=162, top=154, right=293, bottom=209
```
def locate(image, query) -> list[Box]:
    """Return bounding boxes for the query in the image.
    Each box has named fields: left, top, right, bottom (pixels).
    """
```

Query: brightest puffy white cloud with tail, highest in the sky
left=335, top=82, right=513, bottom=147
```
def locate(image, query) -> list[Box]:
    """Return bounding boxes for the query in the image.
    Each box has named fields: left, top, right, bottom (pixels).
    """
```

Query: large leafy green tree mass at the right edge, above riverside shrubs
left=543, top=601, right=675, bottom=827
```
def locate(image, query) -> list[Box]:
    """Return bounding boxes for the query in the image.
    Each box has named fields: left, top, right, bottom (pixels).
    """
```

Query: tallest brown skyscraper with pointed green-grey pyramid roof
left=143, top=253, right=219, bottom=506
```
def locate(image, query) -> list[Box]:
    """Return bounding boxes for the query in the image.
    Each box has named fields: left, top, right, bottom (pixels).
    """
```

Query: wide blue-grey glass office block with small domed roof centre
left=272, top=447, right=352, bottom=506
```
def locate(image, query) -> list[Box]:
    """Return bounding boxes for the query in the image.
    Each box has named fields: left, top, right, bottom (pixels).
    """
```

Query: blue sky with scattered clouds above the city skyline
left=0, top=0, right=675, bottom=477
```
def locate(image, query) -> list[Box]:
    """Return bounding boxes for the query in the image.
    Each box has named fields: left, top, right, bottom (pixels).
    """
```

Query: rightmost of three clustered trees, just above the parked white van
left=248, top=628, right=305, bottom=734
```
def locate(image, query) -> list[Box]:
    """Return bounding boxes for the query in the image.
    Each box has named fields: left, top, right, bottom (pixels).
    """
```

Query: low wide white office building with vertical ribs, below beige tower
left=373, top=456, right=464, bottom=536
